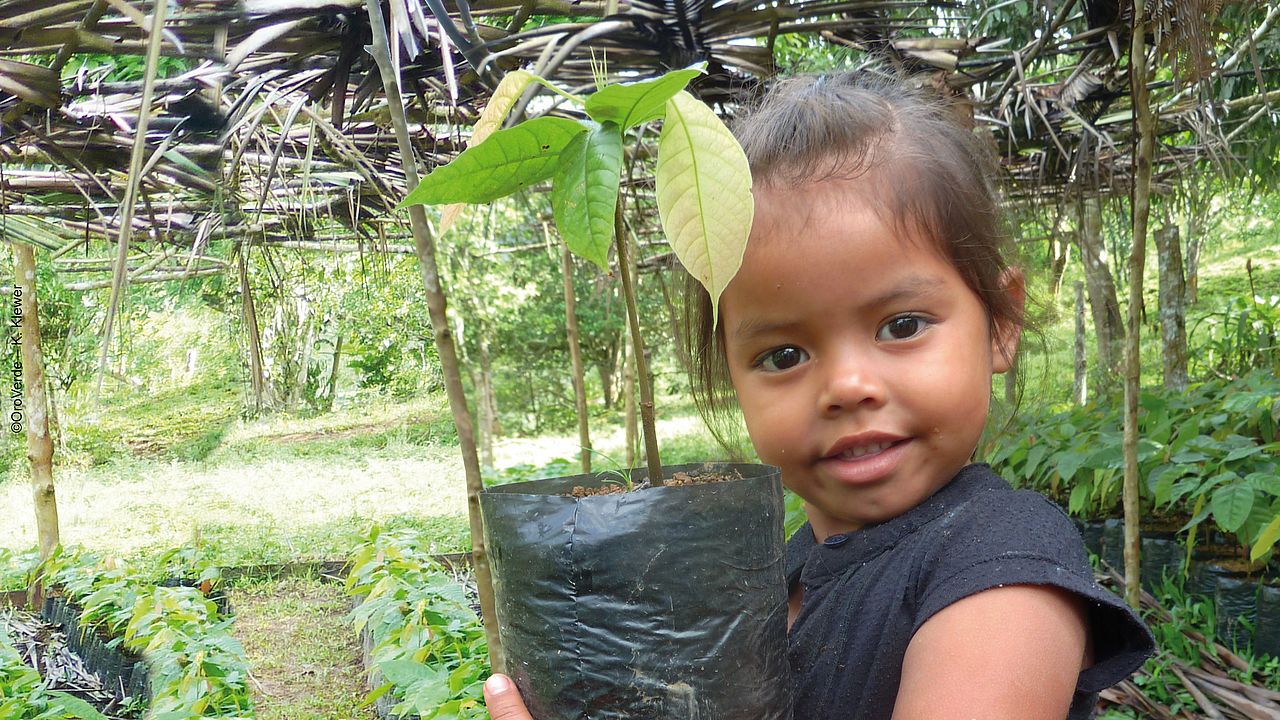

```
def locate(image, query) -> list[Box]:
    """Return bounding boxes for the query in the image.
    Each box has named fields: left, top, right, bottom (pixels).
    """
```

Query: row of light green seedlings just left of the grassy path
left=41, top=548, right=252, bottom=720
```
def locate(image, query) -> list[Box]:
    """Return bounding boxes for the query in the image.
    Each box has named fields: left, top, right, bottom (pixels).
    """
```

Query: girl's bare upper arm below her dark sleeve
left=893, top=585, right=1088, bottom=720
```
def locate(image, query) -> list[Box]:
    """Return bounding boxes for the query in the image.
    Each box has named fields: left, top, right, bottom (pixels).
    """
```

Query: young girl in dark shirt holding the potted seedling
left=485, top=74, right=1153, bottom=720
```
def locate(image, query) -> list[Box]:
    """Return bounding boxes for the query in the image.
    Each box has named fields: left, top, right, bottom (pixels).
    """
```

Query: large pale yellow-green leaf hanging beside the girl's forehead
left=655, top=91, right=755, bottom=322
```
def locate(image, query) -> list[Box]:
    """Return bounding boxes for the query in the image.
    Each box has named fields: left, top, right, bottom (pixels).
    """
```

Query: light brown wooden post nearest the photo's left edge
left=9, top=242, right=58, bottom=602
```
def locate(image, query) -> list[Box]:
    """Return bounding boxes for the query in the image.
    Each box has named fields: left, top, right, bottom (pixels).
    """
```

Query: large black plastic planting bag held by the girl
left=480, top=464, right=791, bottom=720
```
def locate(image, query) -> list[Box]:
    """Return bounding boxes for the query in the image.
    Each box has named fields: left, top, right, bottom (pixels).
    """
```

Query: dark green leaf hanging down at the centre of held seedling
left=552, top=123, right=622, bottom=272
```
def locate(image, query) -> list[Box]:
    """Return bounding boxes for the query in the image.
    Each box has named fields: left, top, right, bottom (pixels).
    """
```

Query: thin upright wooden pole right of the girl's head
left=1124, top=12, right=1156, bottom=610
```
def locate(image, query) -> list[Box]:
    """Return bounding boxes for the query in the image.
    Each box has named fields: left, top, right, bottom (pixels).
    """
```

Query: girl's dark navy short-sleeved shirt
left=787, top=465, right=1155, bottom=720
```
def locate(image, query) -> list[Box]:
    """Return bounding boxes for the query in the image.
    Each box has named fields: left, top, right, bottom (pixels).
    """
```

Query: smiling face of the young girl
left=721, top=181, right=1021, bottom=539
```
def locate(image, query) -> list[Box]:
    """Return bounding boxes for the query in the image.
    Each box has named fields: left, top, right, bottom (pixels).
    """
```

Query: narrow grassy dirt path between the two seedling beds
left=230, top=578, right=376, bottom=720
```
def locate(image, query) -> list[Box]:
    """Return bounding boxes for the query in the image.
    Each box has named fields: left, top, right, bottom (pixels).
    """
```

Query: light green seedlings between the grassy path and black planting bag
left=347, top=527, right=489, bottom=720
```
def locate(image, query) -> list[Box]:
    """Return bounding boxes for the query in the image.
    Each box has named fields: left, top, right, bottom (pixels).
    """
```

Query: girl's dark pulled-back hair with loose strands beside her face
left=684, top=70, right=1023, bottom=450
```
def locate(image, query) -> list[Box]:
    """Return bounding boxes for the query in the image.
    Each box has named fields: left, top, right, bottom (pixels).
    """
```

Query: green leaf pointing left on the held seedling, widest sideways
left=399, top=117, right=586, bottom=208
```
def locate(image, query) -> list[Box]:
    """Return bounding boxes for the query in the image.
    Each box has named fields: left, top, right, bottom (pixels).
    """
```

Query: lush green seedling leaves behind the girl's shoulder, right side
left=989, top=370, right=1280, bottom=557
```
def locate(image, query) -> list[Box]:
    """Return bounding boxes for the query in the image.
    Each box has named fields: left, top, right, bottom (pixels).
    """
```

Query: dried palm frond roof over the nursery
left=0, top=0, right=1280, bottom=285
